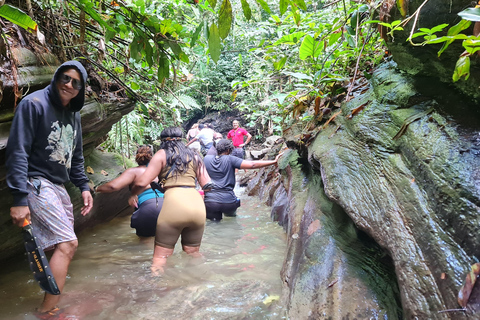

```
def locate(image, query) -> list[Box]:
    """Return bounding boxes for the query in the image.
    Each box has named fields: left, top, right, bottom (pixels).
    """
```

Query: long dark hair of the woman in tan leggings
left=160, top=127, right=203, bottom=176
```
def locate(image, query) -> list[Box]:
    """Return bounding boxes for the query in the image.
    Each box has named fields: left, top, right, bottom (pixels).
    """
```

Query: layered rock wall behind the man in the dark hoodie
left=0, top=48, right=134, bottom=260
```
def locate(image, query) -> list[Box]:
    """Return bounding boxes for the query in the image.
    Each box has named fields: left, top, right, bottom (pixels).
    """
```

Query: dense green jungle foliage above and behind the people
left=0, top=0, right=480, bottom=158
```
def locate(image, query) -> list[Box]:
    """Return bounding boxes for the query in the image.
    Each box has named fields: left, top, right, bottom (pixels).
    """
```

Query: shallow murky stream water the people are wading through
left=0, top=190, right=286, bottom=320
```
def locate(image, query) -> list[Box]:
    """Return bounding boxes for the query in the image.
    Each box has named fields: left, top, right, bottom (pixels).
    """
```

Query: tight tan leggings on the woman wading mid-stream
left=155, top=187, right=206, bottom=249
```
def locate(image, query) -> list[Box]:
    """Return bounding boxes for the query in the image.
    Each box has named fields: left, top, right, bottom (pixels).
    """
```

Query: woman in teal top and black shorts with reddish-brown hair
left=95, top=145, right=163, bottom=237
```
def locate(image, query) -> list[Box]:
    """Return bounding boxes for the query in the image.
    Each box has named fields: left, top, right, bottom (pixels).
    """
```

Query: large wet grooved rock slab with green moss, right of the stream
left=248, top=63, right=480, bottom=319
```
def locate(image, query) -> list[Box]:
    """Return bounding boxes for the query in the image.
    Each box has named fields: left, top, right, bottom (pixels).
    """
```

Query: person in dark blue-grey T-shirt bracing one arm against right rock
left=203, top=139, right=282, bottom=221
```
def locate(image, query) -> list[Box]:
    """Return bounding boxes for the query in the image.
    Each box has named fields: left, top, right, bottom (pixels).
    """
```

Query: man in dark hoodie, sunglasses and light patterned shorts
left=6, top=61, right=93, bottom=315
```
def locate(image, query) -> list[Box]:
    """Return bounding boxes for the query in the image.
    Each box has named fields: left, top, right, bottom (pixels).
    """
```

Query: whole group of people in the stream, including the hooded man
left=6, top=61, right=280, bottom=319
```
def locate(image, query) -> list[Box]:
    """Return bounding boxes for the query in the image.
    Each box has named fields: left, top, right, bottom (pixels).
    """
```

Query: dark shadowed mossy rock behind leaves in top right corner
left=385, top=0, right=480, bottom=101
